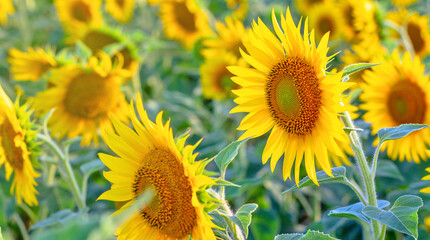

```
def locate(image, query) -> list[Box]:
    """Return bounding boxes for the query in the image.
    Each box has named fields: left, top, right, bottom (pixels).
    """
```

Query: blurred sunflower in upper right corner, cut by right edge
left=387, top=9, right=430, bottom=58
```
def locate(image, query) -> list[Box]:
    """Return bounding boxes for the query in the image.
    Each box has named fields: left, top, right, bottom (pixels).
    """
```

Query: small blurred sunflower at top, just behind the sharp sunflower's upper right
left=308, top=3, right=344, bottom=40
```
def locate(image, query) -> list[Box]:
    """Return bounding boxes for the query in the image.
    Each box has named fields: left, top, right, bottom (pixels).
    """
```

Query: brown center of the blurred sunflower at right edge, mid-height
left=388, top=80, right=427, bottom=124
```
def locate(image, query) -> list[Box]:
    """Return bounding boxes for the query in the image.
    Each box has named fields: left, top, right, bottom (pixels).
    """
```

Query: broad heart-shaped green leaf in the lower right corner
left=362, top=195, right=423, bottom=239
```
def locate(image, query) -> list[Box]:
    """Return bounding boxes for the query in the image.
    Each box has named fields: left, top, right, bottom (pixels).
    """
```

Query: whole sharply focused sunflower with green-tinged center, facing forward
left=228, top=9, right=351, bottom=184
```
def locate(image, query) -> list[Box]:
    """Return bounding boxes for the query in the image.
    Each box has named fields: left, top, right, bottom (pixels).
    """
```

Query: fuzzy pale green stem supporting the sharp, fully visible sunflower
left=340, top=112, right=380, bottom=239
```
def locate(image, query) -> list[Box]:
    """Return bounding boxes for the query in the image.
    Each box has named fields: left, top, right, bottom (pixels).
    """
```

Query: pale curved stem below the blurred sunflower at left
left=37, top=134, right=85, bottom=211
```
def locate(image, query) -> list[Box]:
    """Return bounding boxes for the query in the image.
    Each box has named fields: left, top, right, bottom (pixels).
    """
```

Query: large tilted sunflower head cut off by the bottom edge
left=99, top=95, right=215, bottom=240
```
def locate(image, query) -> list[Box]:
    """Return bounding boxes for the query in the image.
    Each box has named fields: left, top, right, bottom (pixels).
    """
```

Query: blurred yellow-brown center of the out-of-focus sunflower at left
left=64, top=72, right=120, bottom=119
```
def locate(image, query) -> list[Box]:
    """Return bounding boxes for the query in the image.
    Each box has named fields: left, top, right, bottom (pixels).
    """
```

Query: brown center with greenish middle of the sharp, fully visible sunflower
left=266, top=57, right=321, bottom=135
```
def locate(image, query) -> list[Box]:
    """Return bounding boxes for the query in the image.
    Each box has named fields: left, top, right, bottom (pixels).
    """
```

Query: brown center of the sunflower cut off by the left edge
left=0, top=116, right=24, bottom=170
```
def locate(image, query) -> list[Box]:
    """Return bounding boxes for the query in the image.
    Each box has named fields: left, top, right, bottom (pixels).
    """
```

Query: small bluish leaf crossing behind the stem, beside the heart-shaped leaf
left=328, top=200, right=390, bottom=224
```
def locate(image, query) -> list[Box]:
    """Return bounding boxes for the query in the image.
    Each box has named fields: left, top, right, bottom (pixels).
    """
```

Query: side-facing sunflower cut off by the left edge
left=0, top=85, right=40, bottom=206
